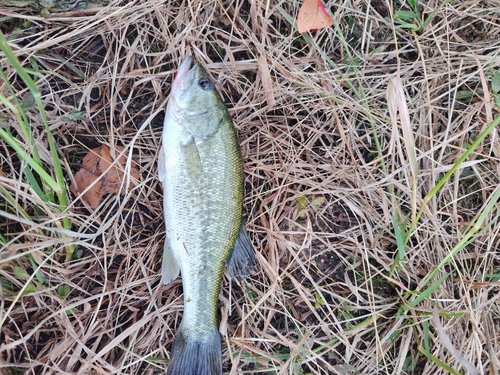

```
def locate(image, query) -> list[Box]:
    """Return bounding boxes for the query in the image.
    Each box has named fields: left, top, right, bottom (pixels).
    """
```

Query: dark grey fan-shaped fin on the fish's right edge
left=226, top=223, right=255, bottom=281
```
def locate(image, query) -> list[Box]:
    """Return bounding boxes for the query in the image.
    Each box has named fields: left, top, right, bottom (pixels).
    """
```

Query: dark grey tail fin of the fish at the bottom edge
left=166, top=324, right=222, bottom=375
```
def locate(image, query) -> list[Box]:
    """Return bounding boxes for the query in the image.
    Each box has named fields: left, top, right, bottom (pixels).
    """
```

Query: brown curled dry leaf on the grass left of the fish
left=71, top=145, right=141, bottom=208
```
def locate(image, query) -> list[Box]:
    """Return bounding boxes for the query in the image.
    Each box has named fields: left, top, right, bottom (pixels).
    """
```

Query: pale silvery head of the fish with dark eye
left=167, top=56, right=228, bottom=139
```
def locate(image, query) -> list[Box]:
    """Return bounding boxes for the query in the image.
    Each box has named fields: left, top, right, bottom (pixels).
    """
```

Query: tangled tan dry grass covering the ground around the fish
left=0, top=0, right=500, bottom=374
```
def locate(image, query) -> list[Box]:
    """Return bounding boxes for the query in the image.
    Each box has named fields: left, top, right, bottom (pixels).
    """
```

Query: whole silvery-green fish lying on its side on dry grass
left=158, top=56, right=255, bottom=375
